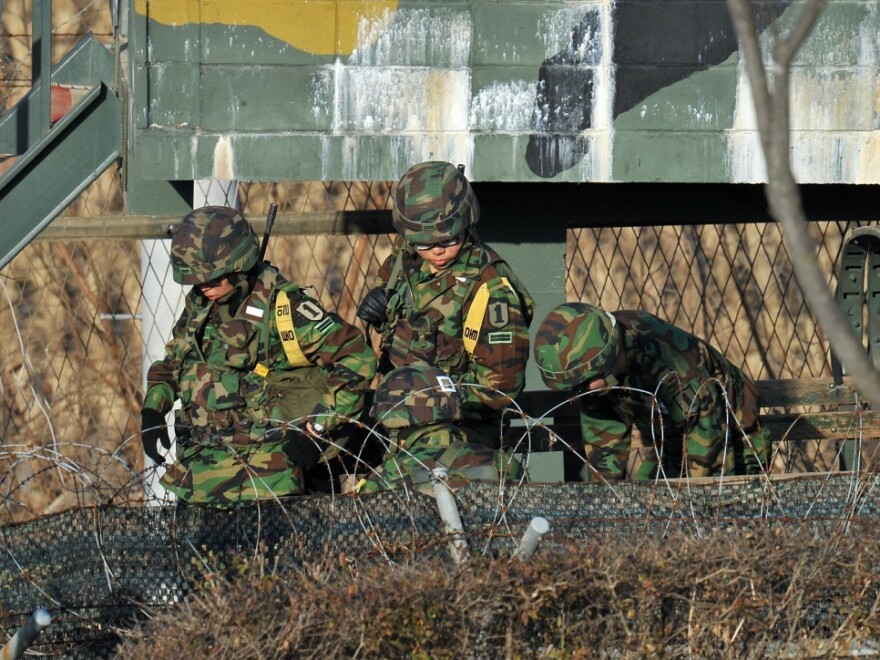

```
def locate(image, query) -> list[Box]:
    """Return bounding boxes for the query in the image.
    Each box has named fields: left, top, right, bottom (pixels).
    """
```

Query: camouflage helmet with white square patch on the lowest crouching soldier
left=371, top=364, right=461, bottom=429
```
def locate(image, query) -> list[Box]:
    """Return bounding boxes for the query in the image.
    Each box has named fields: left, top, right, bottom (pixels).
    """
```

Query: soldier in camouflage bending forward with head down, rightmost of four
left=535, top=303, right=770, bottom=482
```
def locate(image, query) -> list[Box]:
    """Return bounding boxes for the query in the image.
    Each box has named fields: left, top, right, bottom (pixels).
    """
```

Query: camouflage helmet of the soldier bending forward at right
left=535, top=302, right=620, bottom=390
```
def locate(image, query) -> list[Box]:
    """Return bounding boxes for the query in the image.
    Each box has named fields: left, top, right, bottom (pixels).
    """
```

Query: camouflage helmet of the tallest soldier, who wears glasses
left=391, top=161, right=480, bottom=244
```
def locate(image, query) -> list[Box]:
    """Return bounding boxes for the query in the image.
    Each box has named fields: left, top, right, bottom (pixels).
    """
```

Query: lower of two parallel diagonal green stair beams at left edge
left=0, top=84, right=123, bottom=268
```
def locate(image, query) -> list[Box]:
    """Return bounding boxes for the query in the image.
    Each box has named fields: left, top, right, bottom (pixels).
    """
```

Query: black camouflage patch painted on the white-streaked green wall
left=526, top=0, right=791, bottom=179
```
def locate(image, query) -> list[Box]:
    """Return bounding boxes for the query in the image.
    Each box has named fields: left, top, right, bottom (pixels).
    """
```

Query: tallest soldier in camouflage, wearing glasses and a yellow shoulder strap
left=358, top=161, right=534, bottom=447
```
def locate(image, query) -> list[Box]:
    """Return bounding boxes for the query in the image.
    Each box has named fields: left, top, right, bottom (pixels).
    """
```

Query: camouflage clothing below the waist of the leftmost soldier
left=160, top=440, right=303, bottom=506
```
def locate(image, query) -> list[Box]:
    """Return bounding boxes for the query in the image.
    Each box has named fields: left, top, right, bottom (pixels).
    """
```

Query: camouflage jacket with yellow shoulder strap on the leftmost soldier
left=144, top=264, right=376, bottom=443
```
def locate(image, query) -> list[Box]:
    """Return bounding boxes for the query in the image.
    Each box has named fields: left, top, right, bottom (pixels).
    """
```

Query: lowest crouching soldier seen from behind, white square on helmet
left=358, top=365, right=523, bottom=495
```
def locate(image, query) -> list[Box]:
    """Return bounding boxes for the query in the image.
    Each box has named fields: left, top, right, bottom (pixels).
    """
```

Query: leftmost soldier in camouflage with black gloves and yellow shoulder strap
left=141, top=206, right=376, bottom=504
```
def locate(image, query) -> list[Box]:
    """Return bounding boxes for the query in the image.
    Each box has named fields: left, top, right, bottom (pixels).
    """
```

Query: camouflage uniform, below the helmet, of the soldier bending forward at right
left=579, top=311, right=756, bottom=479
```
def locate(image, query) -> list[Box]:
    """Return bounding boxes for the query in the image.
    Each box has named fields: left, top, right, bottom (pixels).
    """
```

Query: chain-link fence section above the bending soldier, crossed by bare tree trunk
left=566, top=222, right=859, bottom=380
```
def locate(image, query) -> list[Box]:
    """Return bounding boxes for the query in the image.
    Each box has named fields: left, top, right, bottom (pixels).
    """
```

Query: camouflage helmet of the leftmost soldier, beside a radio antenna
left=171, top=206, right=260, bottom=284
